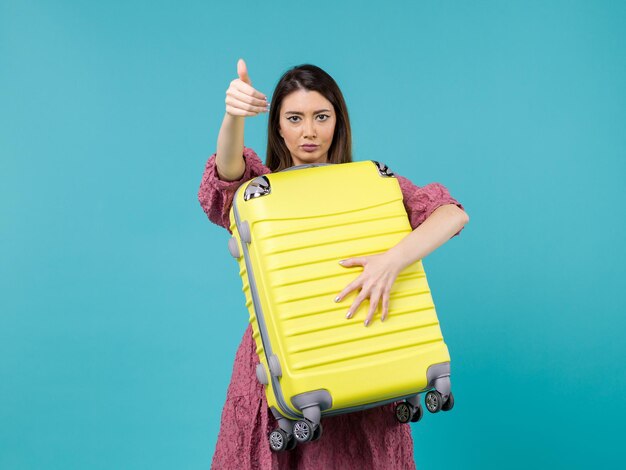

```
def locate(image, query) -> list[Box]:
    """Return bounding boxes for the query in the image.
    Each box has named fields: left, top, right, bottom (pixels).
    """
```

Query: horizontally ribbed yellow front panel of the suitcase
left=246, top=203, right=447, bottom=407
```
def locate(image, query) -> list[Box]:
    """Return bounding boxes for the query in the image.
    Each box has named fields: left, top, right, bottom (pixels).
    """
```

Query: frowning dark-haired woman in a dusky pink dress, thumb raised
left=198, top=60, right=469, bottom=470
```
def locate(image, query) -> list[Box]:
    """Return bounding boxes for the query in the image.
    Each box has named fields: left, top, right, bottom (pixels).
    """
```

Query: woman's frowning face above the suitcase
left=278, top=90, right=336, bottom=165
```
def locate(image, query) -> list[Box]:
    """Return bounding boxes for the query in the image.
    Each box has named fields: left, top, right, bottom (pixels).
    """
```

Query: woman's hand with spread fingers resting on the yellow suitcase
left=335, top=252, right=401, bottom=326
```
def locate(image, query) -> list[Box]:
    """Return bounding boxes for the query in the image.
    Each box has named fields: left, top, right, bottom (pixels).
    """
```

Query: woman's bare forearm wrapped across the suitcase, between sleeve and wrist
left=387, top=204, right=469, bottom=271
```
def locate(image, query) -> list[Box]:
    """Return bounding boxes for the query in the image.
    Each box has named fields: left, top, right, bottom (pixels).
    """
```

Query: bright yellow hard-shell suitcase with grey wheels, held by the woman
left=228, top=161, right=454, bottom=451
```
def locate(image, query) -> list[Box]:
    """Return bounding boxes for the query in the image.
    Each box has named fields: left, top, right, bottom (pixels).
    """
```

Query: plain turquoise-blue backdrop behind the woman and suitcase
left=0, top=0, right=626, bottom=469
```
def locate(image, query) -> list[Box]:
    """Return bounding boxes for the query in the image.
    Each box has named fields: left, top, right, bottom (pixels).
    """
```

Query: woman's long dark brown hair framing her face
left=265, top=64, right=352, bottom=171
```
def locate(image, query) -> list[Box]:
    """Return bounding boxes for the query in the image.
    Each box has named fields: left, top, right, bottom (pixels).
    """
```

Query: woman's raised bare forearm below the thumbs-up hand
left=215, top=113, right=246, bottom=181
